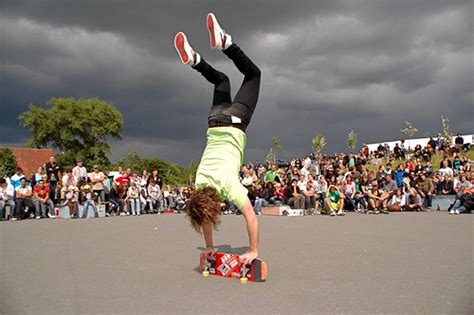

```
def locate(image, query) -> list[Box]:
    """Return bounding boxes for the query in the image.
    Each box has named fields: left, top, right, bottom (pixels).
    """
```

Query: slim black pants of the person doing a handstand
left=194, top=43, right=261, bottom=132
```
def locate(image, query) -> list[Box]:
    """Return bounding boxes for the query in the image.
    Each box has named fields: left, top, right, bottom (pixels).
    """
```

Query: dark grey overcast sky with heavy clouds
left=0, top=0, right=474, bottom=165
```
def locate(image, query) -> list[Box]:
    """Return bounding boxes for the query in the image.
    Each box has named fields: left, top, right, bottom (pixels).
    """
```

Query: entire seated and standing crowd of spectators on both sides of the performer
left=0, top=134, right=474, bottom=220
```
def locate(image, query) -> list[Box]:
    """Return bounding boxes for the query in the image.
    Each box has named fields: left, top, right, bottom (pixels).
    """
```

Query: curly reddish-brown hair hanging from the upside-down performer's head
left=186, top=186, right=222, bottom=233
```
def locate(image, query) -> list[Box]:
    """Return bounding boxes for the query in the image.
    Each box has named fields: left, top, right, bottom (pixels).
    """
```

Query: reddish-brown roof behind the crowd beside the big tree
left=9, top=148, right=54, bottom=178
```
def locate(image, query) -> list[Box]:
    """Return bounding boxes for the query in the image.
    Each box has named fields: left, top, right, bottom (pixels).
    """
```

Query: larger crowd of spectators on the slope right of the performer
left=240, top=135, right=474, bottom=216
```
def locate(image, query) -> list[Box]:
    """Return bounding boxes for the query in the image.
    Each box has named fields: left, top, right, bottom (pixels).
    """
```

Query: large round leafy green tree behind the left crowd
left=18, top=97, right=123, bottom=167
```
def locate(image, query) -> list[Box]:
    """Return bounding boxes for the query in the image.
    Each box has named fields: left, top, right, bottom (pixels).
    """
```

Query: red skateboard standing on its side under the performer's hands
left=199, top=252, right=267, bottom=283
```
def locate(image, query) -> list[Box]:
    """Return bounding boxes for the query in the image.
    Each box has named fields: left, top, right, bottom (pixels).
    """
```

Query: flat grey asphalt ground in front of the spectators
left=0, top=212, right=474, bottom=314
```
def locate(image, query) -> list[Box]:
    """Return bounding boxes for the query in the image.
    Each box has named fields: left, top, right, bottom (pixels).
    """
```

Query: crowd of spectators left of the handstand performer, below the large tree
left=0, top=157, right=192, bottom=221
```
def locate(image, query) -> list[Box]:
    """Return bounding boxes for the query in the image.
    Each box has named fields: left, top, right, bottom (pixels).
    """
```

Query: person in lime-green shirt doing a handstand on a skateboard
left=174, top=13, right=261, bottom=264
